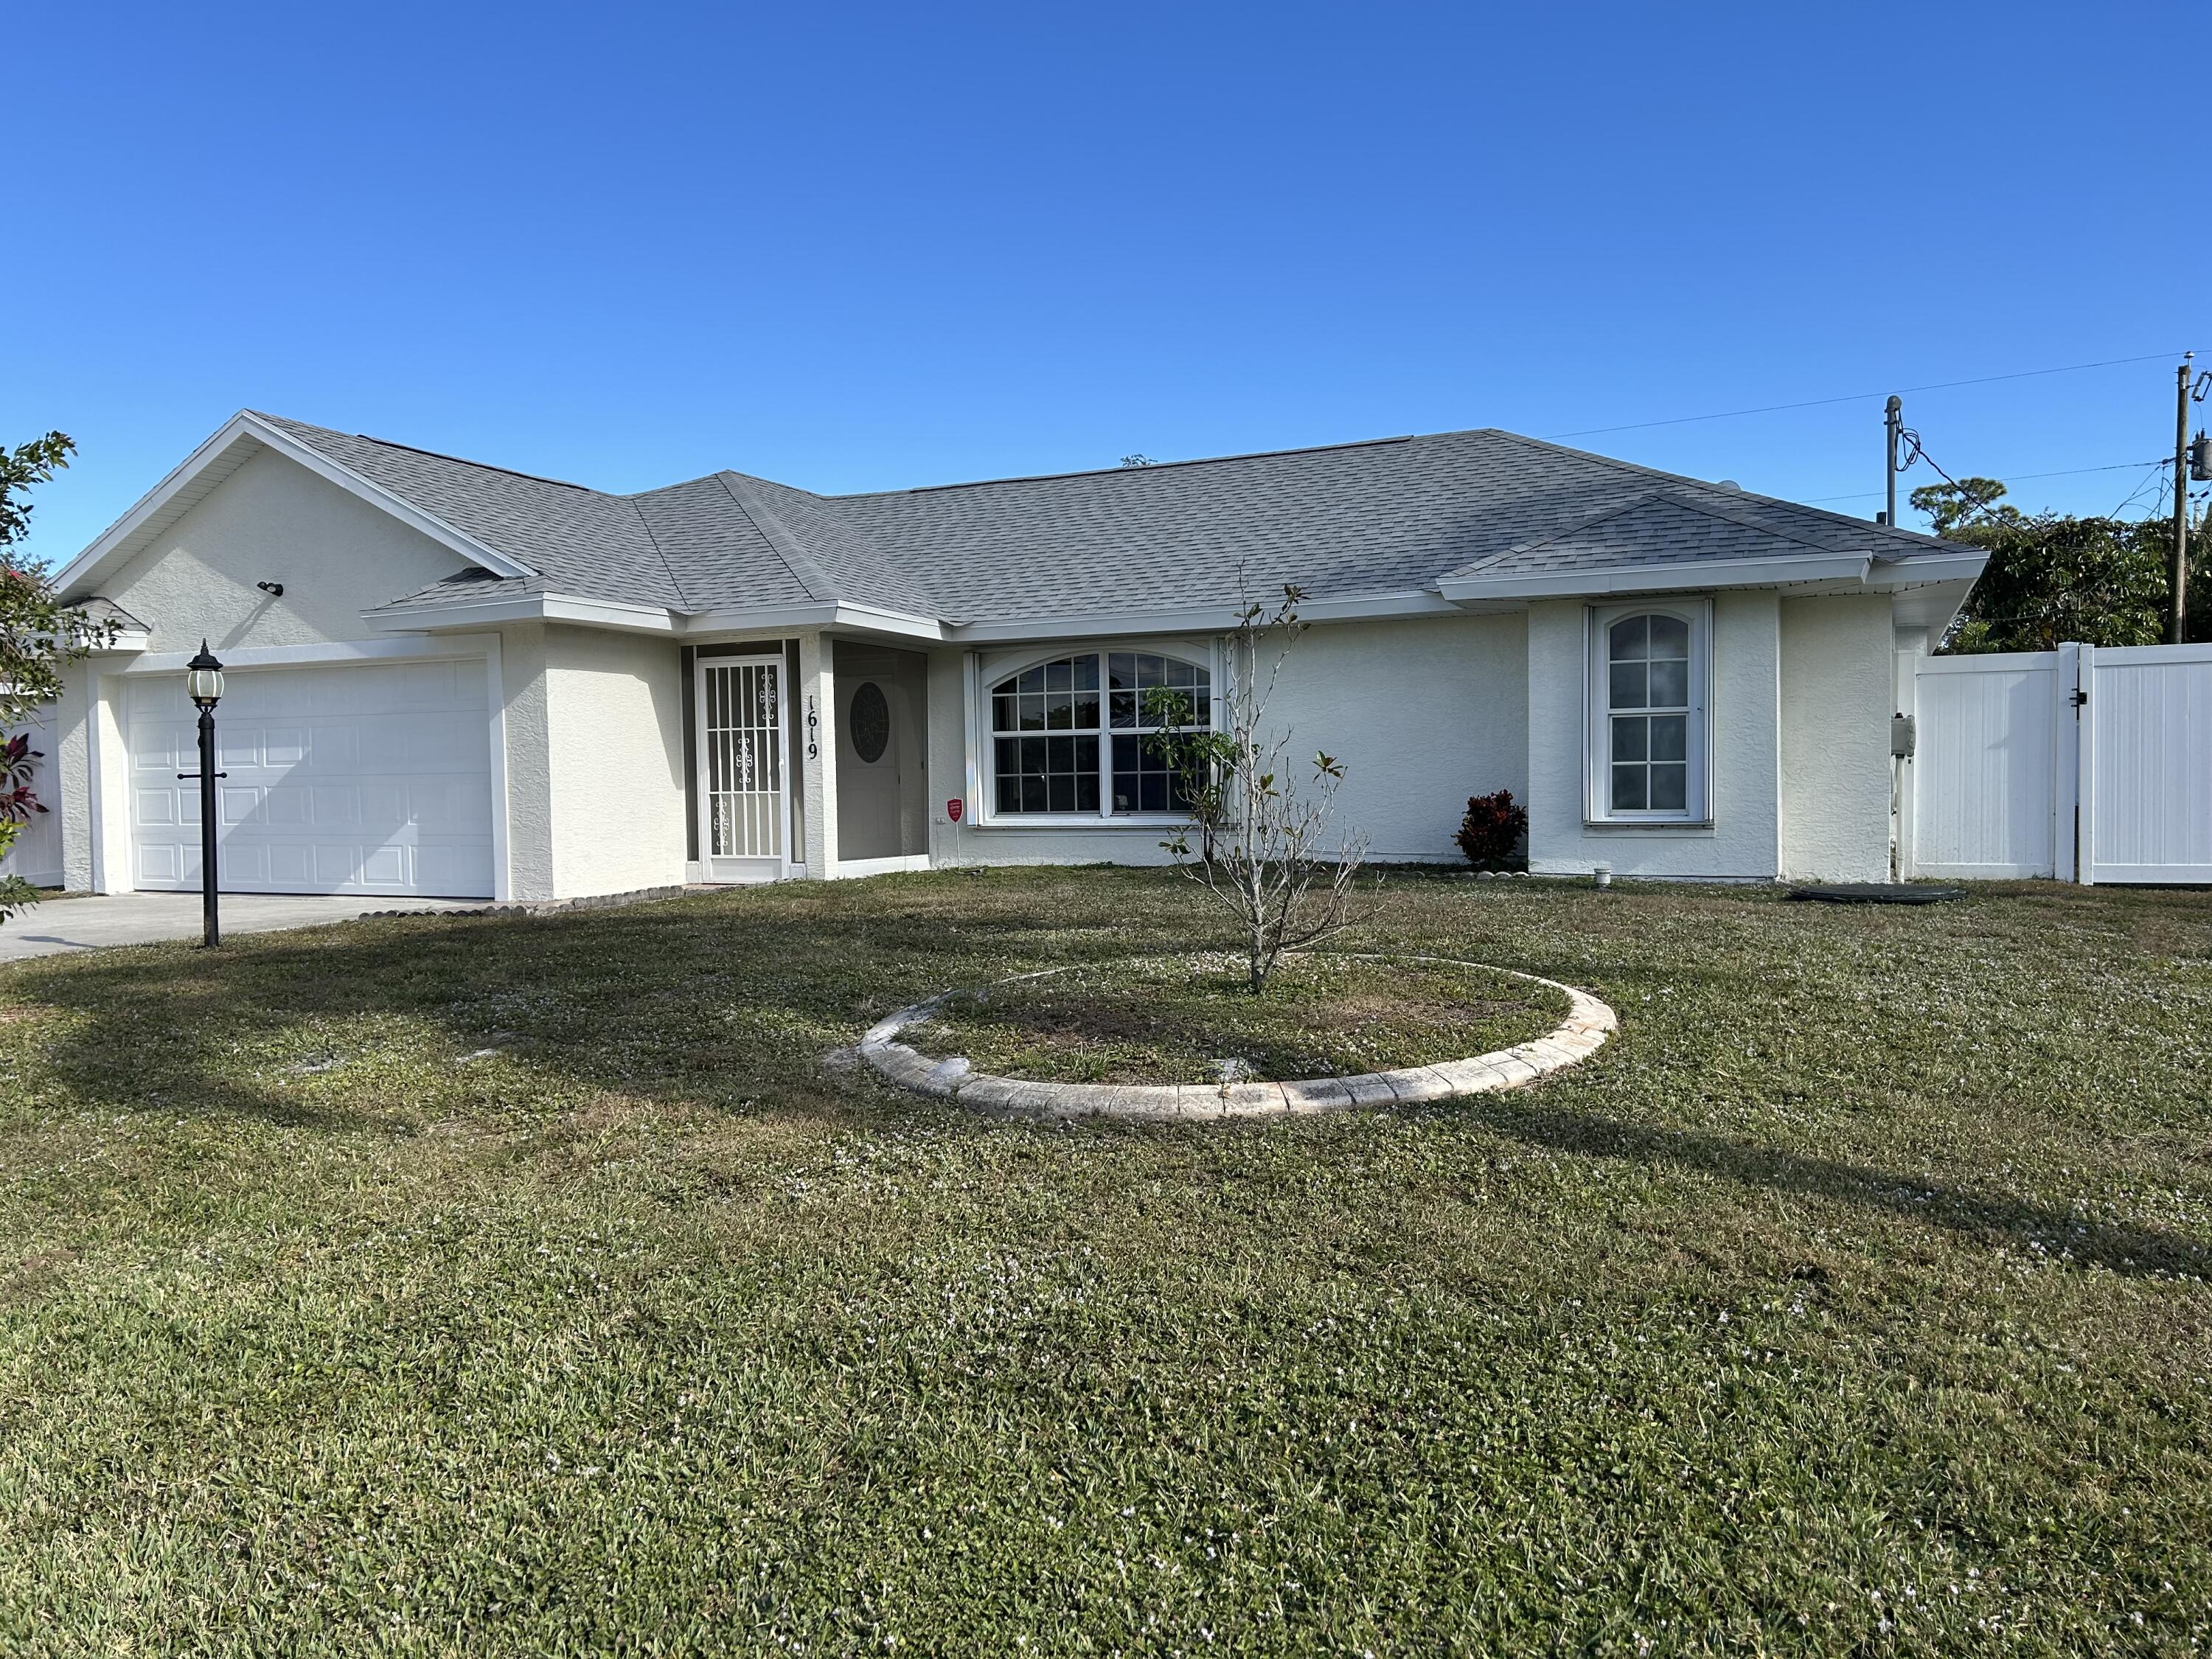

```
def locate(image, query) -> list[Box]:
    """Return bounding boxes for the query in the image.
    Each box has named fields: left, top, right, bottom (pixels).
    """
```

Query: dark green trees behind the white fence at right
left=1911, top=478, right=2212, bottom=653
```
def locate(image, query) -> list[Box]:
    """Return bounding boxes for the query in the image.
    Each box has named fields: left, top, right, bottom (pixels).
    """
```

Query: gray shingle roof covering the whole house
left=265, top=416, right=1949, bottom=622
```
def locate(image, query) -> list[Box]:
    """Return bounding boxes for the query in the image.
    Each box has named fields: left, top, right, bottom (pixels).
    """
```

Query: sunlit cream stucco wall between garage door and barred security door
left=538, top=626, right=684, bottom=898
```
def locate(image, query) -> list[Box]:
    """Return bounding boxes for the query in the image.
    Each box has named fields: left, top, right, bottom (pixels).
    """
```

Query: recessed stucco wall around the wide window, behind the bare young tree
left=929, top=615, right=1528, bottom=865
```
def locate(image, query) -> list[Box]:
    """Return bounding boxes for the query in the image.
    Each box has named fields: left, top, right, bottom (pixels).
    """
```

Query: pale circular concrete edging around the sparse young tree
left=858, top=951, right=1621, bottom=1121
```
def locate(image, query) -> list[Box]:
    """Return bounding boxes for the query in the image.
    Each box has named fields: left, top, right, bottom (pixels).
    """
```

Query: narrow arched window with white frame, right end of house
left=1590, top=604, right=1710, bottom=823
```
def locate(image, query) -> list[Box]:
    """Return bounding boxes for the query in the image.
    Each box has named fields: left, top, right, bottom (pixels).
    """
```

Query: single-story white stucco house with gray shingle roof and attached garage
left=17, top=414, right=1982, bottom=900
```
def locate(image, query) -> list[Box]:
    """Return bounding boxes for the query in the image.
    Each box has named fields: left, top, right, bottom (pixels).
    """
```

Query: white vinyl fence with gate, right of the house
left=1898, top=646, right=2212, bottom=883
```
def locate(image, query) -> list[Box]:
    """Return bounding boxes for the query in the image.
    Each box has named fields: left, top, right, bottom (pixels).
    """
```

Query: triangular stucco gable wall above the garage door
left=91, top=451, right=462, bottom=655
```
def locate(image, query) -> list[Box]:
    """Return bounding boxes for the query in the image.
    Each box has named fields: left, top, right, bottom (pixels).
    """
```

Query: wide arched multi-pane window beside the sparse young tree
left=991, top=650, right=1214, bottom=816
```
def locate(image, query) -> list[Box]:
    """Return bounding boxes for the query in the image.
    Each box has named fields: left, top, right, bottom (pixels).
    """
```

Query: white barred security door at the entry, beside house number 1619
left=697, top=657, right=792, bottom=880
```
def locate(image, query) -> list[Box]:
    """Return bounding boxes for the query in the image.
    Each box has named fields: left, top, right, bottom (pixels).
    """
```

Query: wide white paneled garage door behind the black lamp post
left=124, top=659, right=491, bottom=898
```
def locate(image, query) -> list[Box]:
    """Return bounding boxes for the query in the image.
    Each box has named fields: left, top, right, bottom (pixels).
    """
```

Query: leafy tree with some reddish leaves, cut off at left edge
left=0, top=431, right=100, bottom=920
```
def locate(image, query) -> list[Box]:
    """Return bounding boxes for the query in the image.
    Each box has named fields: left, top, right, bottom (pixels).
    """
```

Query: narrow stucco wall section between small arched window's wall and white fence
left=1781, top=593, right=1896, bottom=880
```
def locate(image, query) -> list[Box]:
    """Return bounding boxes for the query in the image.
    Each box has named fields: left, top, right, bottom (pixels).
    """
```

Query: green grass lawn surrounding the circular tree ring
left=0, top=869, right=2212, bottom=1655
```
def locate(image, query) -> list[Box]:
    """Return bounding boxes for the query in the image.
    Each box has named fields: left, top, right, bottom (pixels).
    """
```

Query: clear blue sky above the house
left=0, top=2, right=2212, bottom=560
